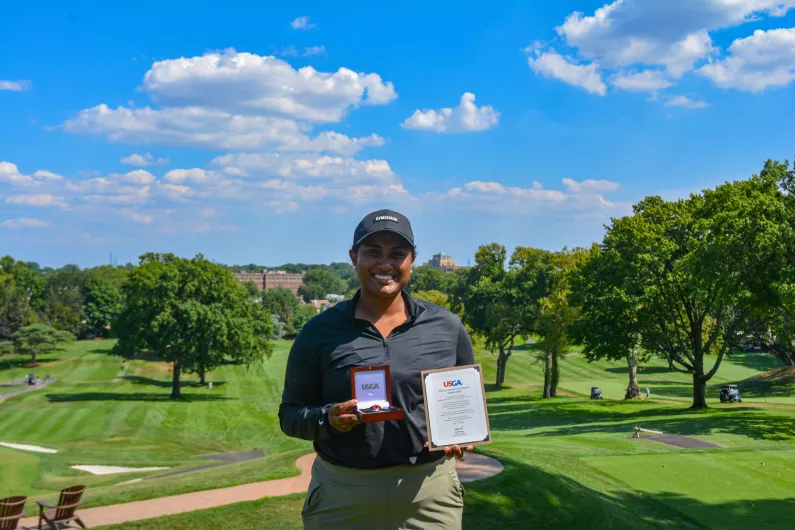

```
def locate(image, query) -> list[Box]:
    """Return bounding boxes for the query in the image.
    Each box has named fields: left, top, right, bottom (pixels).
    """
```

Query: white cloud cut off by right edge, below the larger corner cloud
left=699, top=28, right=795, bottom=92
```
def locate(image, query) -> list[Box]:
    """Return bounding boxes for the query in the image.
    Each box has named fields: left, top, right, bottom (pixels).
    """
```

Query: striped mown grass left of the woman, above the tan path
left=0, top=341, right=311, bottom=506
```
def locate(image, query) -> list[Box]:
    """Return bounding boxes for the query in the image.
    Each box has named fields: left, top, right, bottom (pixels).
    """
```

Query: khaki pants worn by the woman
left=301, top=456, right=464, bottom=530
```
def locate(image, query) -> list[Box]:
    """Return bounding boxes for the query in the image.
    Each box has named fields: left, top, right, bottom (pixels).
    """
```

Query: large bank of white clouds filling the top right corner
left=548, top=0, right=795, bottom=99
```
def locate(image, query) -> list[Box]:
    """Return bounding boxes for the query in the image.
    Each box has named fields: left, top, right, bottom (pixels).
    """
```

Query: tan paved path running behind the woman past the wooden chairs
left=20, top=453, right=503, bottom=530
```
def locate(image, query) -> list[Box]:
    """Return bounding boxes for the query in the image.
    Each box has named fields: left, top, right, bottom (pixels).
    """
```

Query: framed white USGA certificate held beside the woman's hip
left=421, top=364, right=491, bottom=451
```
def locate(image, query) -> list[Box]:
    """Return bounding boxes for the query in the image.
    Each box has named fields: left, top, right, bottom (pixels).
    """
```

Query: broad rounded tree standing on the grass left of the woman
left=113, top=253, right=272, bottom=399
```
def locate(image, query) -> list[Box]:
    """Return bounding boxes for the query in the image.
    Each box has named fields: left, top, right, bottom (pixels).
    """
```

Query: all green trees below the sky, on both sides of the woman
left=0, top=160, right=795, bottom=408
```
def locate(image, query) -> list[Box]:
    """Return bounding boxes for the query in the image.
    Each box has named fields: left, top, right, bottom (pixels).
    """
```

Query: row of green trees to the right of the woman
left=410, top=160, right=795, bottom=408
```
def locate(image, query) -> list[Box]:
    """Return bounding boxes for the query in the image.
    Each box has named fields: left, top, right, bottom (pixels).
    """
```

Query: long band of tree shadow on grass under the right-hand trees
left=489, top=398, right=795, bottom=441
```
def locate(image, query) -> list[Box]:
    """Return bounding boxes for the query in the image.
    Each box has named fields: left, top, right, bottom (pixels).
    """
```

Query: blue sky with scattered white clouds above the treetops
left=0, top=0, right=795, bottom=266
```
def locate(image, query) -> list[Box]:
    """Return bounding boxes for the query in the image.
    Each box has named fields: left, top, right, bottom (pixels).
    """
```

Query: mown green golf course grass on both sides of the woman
left=0, top=336, right=795, bottom=530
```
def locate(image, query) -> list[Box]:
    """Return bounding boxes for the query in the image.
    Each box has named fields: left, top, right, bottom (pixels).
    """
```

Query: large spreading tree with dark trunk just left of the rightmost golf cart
left=601, top=177, right=771, bottom=409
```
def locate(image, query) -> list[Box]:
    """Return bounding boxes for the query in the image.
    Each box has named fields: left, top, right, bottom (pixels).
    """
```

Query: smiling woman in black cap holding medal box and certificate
left=279, top=210, right=474, bottom=530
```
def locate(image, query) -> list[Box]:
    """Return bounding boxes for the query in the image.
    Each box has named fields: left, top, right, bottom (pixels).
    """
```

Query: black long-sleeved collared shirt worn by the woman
left=279, top=292, right=475, bottom=469
